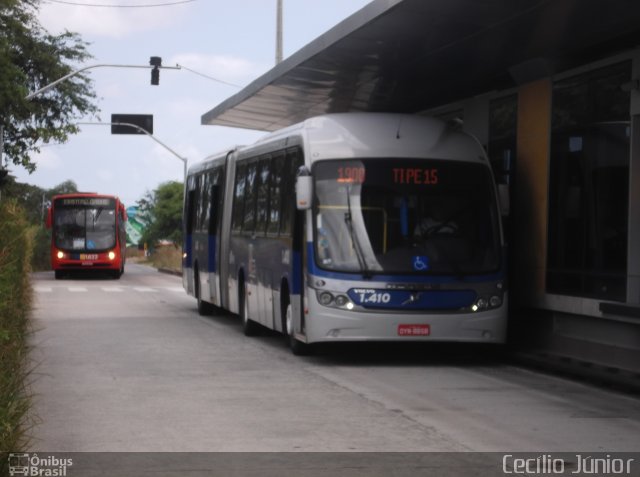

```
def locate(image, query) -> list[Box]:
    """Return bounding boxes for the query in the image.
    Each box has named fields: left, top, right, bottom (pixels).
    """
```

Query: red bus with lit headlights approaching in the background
left=47, top=193, right=127, bottom=279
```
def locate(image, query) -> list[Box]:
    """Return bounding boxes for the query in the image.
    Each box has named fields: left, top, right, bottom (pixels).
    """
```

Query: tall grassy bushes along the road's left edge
left=0, top=200, right=34, bottom=454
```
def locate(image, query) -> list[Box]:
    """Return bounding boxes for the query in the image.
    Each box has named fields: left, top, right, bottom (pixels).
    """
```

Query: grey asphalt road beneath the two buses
left=26, top=265, right=640, bottom=470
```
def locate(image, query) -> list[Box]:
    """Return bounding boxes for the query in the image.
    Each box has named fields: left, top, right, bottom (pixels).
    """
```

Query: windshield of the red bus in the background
left=53, top=197, right=116, bottom=252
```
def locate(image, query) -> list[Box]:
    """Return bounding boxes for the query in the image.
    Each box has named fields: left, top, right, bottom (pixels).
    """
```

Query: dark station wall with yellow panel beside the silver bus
left=424, top=50, right=640, bottom=376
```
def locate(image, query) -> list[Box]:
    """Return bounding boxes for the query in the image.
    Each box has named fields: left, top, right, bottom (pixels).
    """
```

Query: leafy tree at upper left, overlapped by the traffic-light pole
left=0, top=0, right=98, bottom=172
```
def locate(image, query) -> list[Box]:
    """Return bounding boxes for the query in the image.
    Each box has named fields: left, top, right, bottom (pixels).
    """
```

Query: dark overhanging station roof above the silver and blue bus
left=201, top=0, right=640, bottom=131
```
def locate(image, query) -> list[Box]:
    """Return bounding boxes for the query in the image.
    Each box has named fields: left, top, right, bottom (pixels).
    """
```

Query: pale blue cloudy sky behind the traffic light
left=9, top=0, right=371, bottom=206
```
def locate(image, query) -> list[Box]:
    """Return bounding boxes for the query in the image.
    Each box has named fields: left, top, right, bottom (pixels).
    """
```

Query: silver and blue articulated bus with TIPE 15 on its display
left=183, top=113, right=507, bottom=354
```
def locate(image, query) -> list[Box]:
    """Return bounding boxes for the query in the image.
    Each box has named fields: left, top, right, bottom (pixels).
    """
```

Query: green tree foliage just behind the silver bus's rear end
left=137, top=181, right=183, bottom=244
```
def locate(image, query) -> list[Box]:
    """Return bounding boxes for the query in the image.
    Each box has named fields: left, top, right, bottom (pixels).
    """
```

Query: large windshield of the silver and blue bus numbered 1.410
left=313, top=159, right=500, bottom=276
